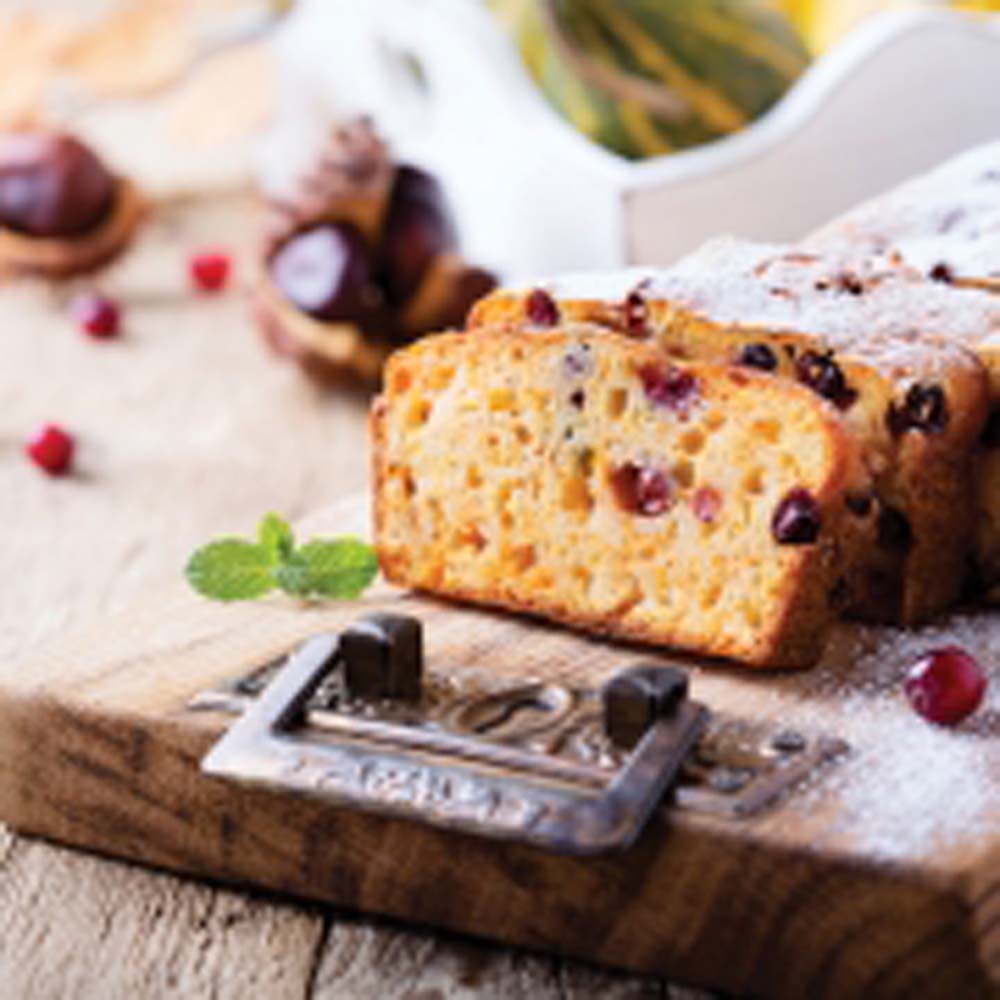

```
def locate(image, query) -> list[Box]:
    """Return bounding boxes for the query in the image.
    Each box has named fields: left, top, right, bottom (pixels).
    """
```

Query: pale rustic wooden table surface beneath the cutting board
left=0, top=196, right=703, bottom=1000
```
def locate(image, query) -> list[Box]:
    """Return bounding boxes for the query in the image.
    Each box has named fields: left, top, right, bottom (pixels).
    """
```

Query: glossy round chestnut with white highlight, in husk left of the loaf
left=271, top=223, right=373, bottom=321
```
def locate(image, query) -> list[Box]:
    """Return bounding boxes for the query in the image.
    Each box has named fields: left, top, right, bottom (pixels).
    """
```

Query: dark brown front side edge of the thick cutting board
left=0, top=691, right=988, bottom=997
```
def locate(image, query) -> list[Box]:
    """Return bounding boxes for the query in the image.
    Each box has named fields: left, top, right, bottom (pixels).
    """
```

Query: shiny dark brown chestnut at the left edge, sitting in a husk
left=0, top=132, right=115, bottom=237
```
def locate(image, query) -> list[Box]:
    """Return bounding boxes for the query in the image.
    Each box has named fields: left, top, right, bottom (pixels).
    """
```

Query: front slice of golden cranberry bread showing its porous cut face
left=371, top=324, right=855, bottom=667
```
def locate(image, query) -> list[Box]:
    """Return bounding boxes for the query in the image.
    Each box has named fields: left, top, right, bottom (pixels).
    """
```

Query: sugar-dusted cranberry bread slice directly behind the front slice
left=471, top=240, right=996, bottom=624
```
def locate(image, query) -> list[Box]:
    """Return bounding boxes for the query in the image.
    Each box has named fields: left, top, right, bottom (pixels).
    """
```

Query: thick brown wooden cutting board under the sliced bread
left=0, top=502, right=1000, bottom=997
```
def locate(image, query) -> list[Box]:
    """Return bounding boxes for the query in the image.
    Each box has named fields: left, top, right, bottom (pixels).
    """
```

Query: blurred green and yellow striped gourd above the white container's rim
left=491, top=0, right=809, bottom=159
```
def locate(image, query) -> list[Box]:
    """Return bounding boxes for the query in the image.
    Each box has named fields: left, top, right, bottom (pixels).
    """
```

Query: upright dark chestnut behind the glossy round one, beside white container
left=382, top=166, right=457, bottom=303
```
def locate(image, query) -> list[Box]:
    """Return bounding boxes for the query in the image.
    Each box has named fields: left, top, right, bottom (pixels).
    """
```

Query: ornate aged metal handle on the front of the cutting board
left=202, top=615, right=708, bottom=854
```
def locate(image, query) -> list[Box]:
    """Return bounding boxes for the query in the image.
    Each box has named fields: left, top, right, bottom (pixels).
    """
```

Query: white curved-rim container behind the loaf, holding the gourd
left=261, top=0, right=1000, bottom=280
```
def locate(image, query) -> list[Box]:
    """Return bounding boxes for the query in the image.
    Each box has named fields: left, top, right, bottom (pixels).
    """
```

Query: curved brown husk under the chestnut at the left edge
left=0, top=178, right=143, bottom=278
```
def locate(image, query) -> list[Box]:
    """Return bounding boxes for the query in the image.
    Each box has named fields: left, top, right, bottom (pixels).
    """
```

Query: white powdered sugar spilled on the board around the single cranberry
left=696, top=611, right=1000, bottom=864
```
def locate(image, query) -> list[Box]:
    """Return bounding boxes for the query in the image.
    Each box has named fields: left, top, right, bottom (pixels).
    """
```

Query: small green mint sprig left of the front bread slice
left=184, top=513, right=378, bottom=601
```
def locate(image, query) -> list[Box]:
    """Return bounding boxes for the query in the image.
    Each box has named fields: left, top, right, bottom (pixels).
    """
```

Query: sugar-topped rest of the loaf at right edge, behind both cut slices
left=810, top=142, right=1000, bottom=601
